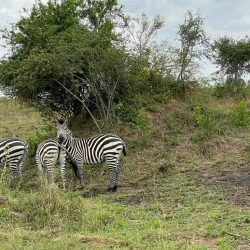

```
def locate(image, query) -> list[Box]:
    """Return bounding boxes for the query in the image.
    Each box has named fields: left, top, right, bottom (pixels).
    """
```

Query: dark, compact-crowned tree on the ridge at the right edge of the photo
left=213, top=37, right=250, bottom=84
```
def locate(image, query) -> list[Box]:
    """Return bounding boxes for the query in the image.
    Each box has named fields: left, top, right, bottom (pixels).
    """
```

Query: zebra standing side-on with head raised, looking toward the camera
left=57, top=120, right=126, bottom=192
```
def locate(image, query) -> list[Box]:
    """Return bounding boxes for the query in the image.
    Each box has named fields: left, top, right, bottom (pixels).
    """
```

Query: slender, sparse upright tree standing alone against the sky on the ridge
left=176, top=11, right=209, bottom=83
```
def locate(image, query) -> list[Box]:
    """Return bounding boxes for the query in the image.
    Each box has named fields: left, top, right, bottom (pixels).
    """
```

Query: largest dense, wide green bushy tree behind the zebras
left=0, top=0, right=125, bottom=121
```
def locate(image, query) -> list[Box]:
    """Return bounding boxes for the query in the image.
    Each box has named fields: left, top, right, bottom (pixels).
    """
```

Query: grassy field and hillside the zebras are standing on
left=0, top=95, right=250, bottom=250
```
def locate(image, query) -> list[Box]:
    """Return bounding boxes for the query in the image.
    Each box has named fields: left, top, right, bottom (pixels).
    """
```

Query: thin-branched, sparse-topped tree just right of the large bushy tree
left=123, top=14, right=173, bottom=100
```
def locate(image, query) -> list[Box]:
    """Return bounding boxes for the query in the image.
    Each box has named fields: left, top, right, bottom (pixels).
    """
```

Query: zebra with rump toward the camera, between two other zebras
left=36, top=139, right=79, bottom=191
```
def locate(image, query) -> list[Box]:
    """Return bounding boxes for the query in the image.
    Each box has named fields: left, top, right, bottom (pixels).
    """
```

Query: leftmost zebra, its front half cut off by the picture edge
left=0, top=138, right=27, bottom=187
